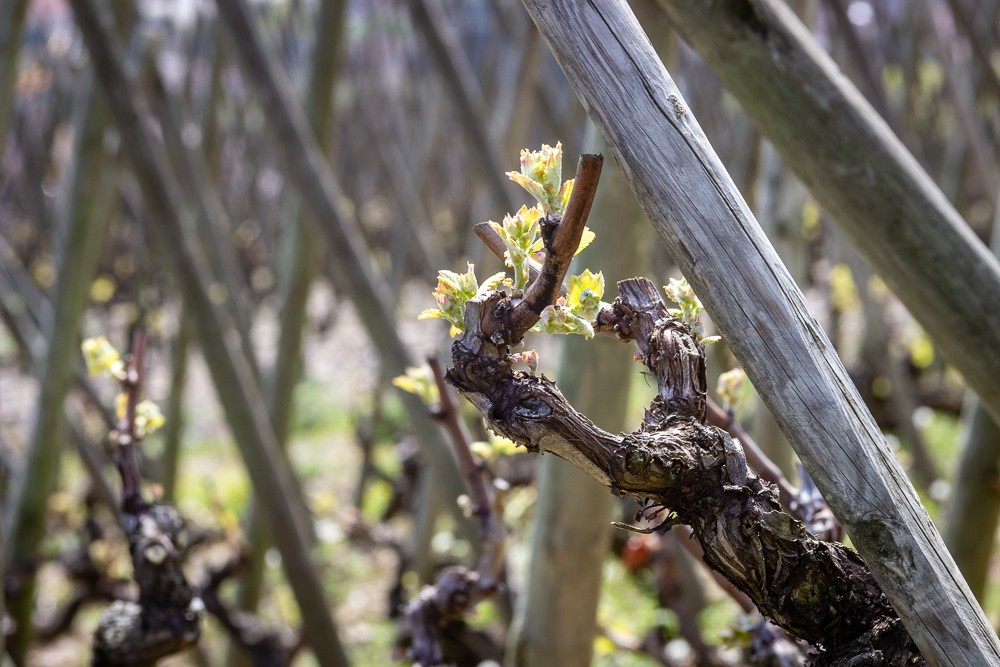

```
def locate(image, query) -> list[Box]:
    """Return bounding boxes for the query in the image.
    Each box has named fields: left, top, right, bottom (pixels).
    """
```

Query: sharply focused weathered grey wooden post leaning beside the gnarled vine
left=525, top=0, right=1000, bottom=665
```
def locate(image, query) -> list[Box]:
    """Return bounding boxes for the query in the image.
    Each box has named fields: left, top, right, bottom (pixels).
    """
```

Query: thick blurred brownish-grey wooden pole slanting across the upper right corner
left=661, top=0, right=1000, bottom=428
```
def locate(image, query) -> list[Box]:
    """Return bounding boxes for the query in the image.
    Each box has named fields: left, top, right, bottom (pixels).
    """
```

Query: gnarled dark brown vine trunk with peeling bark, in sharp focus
left=448, top=279, right=922, bottom=665
